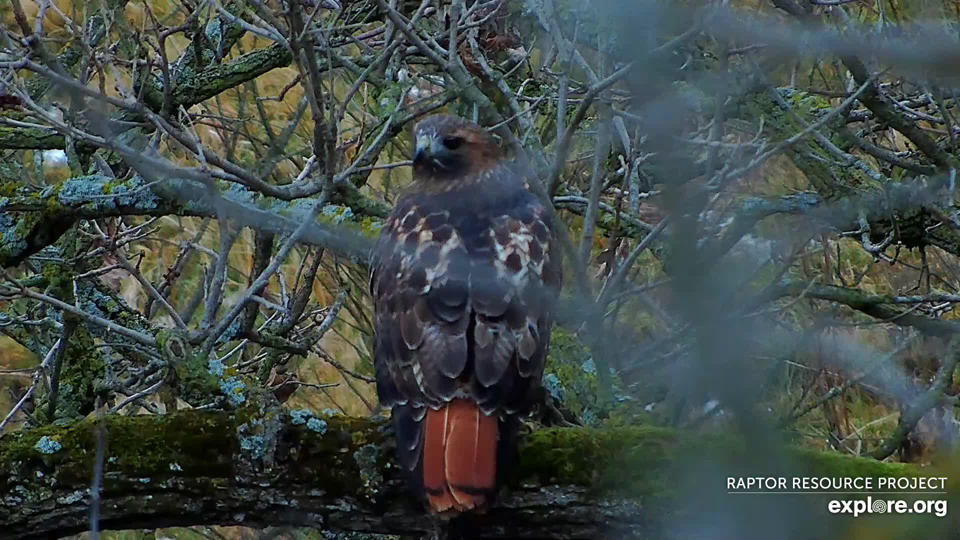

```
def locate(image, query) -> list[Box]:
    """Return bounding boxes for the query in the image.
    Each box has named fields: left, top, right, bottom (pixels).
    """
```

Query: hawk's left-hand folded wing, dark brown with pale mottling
left=371, top=197, right=469, bottom=407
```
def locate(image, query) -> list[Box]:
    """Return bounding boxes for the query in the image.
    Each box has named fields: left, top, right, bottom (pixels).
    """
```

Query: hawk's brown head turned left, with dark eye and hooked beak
left=413, top=115, right=498, bottom=180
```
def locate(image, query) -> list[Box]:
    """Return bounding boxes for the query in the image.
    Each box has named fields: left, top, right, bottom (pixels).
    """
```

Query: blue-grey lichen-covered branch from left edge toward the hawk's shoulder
left=0, top=175, right=387, bottom=268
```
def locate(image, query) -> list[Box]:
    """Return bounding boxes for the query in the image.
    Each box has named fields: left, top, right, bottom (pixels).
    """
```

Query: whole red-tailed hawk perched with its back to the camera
left=370, top=115, right=563, bottom=512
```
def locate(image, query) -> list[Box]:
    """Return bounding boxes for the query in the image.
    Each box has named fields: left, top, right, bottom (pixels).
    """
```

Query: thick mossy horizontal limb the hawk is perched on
left=0, top=408, right=933, bottom=540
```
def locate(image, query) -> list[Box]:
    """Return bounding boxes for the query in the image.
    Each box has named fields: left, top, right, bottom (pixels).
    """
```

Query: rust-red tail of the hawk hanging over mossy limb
left=423, top=399, right=497, bottom=512
